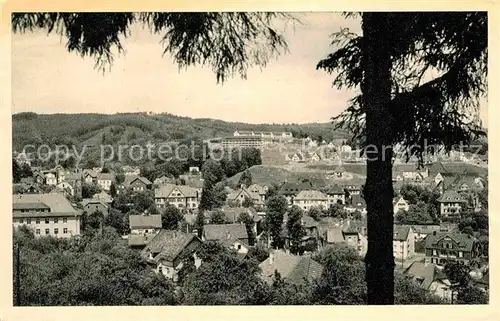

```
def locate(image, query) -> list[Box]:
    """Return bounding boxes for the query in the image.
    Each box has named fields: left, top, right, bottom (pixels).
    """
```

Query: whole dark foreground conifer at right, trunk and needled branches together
left=317, top=12, right=488, bottom=304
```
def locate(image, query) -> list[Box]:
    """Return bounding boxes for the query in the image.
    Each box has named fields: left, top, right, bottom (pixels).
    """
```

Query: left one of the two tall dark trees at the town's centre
left=264, top=196, right=288, bottom=248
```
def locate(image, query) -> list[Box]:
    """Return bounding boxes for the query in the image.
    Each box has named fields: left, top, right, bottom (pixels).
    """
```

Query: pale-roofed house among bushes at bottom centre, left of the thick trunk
left=259, top=250, right=323, bottom=285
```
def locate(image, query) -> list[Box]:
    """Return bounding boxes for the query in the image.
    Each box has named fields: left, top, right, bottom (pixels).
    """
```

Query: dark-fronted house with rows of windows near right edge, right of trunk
left=425, top=232, right=480, bottom=265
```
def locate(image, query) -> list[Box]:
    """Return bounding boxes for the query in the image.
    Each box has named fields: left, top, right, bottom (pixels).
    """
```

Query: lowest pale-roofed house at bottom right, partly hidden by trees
left=403, top=262, right=452, bottom=301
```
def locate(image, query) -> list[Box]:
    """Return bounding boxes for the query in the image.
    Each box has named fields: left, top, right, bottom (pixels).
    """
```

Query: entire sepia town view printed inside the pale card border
left=11, top=12, right=490, bottom=306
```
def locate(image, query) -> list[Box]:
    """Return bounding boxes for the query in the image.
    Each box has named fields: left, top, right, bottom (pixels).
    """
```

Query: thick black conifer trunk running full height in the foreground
left=361, top=13, right=394, bottom=304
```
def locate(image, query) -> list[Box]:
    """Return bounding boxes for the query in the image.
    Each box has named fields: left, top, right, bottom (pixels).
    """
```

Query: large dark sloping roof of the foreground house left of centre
left=141, top=230, right=201, bottom=262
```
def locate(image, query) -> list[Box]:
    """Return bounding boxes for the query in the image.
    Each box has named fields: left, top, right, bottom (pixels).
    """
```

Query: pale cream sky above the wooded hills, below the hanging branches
left=12, top=13, right=487, bottom=123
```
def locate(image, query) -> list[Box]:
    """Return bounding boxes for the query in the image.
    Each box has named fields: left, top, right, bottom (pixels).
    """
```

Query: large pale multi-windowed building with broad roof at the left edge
left=12, top=193, right=81, bottom=237
